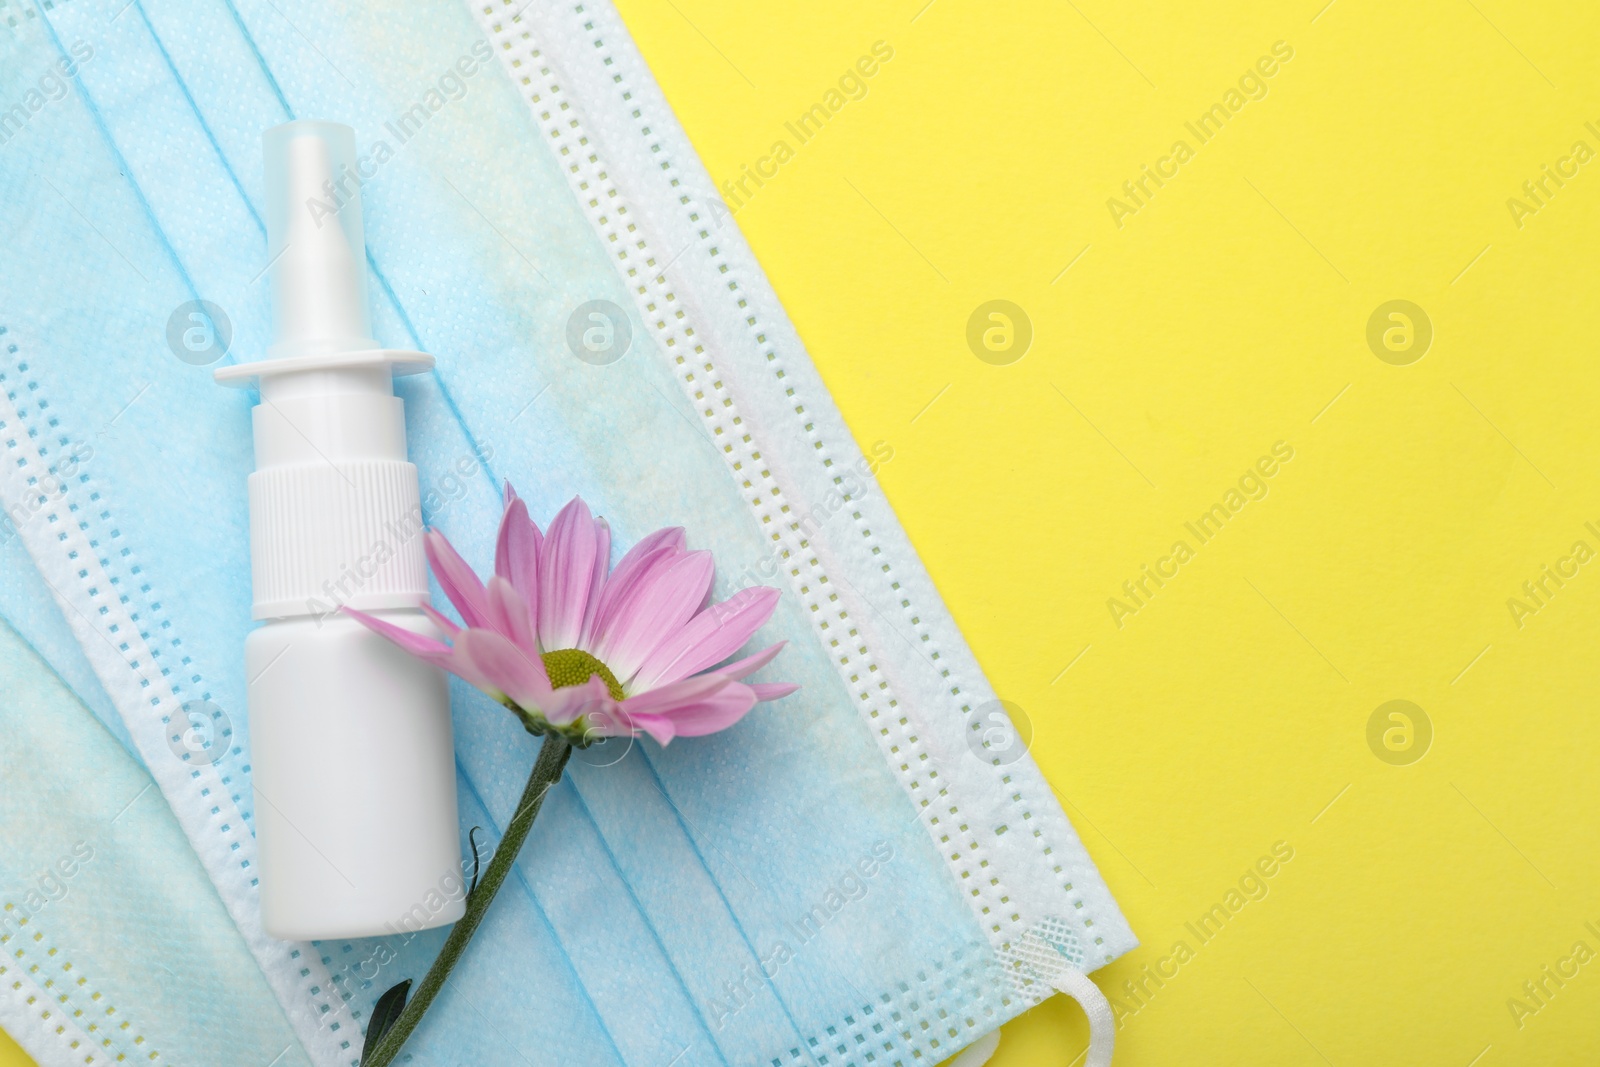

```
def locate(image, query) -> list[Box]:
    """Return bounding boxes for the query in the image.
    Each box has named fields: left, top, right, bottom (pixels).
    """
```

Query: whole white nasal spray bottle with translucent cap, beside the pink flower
left=216, top=122, right=464, bottom=941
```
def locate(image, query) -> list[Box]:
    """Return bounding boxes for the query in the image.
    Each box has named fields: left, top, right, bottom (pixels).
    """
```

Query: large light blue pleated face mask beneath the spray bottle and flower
left=0, top=0, right=1136, bottom=1067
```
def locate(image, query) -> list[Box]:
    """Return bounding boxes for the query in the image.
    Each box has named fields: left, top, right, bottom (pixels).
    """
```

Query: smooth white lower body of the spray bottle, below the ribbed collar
left=245, top=609, right=466, bottom=941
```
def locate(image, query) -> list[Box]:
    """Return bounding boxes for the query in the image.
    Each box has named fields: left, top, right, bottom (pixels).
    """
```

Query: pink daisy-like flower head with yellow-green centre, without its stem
left=346, top=485, right=800, bottom=745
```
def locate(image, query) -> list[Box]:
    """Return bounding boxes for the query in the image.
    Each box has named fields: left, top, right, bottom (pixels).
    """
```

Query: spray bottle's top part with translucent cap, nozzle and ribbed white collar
left=216, top=120, right=434, bottom=619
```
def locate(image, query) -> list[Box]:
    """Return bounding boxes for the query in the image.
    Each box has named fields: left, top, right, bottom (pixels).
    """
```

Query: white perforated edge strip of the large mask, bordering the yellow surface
left=466, top=0, right=1138, bottom=1056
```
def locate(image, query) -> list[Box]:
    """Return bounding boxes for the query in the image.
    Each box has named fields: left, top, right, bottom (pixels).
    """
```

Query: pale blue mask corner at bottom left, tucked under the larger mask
left=0, top=624, right=309, bottom=1067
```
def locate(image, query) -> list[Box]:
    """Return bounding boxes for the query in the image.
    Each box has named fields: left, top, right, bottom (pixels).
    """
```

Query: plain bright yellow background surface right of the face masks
left=0, top=0, right=1600, bottom=1067
